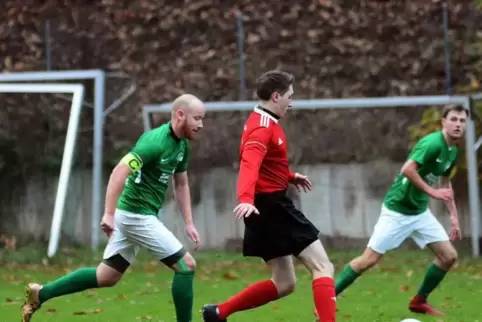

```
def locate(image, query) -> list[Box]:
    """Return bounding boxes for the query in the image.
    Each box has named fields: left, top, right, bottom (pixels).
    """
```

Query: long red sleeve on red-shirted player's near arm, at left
left=236, top=127, right=272, bottom=204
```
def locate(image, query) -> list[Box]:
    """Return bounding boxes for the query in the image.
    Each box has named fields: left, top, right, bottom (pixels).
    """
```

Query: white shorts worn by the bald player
left=103, top=209, right=183, bottom=264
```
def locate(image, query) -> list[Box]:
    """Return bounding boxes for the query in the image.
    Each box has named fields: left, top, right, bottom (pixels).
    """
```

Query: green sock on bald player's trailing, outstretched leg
left=39, top=267, right=98, bottom=303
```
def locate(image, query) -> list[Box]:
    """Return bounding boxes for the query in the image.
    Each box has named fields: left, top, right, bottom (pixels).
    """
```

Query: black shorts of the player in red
left=243, top=191, right=319, bottom=261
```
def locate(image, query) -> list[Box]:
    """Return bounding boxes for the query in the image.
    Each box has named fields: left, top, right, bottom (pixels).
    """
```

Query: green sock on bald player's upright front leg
left=171, top=271, right=194, bottom=322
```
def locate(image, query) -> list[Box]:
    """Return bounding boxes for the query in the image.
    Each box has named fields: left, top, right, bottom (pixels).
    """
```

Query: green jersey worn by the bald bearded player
left=117, top=122, right=190, bottom=216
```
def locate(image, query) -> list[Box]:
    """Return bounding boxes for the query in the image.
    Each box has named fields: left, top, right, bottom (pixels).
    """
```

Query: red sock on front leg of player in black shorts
left=312, top=277, right=336, bottom=322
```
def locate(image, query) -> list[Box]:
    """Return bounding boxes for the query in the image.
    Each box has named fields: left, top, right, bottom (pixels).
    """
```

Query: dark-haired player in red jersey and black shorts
left=203, top=71, right=336, bottom=322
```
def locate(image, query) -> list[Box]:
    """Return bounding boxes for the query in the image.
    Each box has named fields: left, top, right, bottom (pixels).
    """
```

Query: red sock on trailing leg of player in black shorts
left=218, top=280, right=280, bottom=321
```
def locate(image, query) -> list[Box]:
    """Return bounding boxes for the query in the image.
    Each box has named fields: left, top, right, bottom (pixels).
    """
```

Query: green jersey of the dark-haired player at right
left=383, top=131, right=457, bottom=215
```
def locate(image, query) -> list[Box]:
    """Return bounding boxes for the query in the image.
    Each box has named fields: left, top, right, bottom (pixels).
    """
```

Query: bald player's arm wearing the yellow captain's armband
left=100, top=153, right=137, bottom=236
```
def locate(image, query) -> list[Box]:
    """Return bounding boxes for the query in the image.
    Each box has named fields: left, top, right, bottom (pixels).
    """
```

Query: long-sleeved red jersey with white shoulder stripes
left=237, top=107, right=295, bottom=204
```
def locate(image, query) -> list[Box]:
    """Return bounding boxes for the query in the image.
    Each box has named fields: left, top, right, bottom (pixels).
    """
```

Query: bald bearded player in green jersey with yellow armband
left=22, top=94, right=205, bottom=322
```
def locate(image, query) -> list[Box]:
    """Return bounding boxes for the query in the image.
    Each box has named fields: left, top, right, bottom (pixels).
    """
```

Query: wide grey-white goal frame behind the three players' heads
left=142, top=95, right=480, bottom=257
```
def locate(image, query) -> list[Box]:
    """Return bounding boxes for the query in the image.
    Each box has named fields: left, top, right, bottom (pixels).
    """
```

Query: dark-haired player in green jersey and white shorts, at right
left=320, top=105, right=468, bottom=315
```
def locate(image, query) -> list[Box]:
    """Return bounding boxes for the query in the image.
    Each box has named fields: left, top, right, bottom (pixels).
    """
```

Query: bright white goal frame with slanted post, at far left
left=0, top=83, right=84, bottom=257
